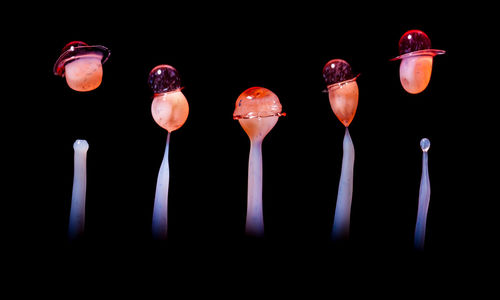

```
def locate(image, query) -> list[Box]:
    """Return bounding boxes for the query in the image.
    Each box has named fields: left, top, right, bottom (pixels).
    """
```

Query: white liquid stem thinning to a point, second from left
left=152, top=132, right=170, bottom=240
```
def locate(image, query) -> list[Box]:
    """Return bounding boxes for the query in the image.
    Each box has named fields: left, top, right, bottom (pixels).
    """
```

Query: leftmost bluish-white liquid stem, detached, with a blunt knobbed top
left=68, top=140, right=89, bottom=240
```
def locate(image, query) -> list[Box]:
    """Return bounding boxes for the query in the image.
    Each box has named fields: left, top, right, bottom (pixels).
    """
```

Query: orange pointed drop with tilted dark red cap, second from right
left=323, top=59, right=359, bottom=127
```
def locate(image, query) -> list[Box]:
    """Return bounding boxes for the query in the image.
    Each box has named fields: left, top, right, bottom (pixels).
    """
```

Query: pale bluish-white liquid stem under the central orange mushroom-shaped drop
left=245, top=139, right=264, bottom=237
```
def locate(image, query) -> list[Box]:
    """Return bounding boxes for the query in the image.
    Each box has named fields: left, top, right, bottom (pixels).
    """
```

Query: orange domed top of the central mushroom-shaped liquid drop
left=233, top=87, right=284, bottom=120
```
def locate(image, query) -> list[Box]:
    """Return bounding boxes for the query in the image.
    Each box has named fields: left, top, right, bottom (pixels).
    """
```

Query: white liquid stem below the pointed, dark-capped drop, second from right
left=332, top=127, right=354, bottom=240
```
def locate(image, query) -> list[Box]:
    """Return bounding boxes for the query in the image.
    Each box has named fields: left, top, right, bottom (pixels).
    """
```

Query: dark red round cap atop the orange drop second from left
left=148, top=65, right=181, bottom=94
